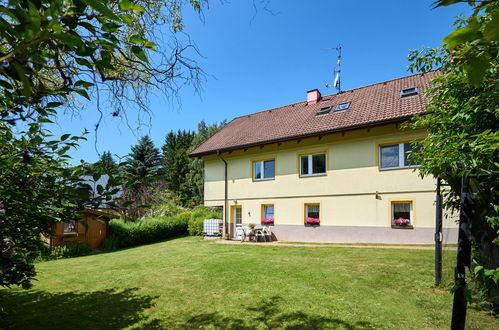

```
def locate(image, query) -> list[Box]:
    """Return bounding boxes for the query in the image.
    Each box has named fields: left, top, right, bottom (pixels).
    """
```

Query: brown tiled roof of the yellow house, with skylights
left=190, top=71, right=437, bottom=156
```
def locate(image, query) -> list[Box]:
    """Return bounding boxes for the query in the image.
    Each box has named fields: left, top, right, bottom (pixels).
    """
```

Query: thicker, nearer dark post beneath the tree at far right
left=451, top=175, right=473, bottom=330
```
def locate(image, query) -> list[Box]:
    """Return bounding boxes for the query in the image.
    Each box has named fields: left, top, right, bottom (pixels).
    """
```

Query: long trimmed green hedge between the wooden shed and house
left=103, top=216, right=188, bottom=251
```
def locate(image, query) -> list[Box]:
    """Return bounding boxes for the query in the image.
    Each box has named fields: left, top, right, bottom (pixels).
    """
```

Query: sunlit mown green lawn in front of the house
left=0, top=237, right=499, bottom=329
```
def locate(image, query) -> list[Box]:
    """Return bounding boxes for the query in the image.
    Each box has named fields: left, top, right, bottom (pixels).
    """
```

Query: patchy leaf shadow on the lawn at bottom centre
left=179, top=296, right=376, bottom=330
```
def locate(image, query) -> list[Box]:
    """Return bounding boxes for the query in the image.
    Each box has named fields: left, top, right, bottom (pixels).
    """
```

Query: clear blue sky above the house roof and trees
left=52, top=0, right=467, bottom=163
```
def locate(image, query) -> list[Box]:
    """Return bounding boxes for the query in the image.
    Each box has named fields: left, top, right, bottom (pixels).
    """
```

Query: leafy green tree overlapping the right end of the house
left=409, top=0, right=499, bottom=306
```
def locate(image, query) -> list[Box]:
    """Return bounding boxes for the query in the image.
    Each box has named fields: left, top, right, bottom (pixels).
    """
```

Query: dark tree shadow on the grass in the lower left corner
left=0, top=288, right=157, bottom=329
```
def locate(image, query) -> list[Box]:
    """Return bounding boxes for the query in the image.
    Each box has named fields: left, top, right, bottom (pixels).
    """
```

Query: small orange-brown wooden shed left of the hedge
left=48, top=209, right=118, bottom=249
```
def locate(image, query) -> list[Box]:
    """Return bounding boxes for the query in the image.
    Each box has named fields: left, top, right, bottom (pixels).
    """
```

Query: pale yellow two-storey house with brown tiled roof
left=191, top=72, right=457, bottom=244
